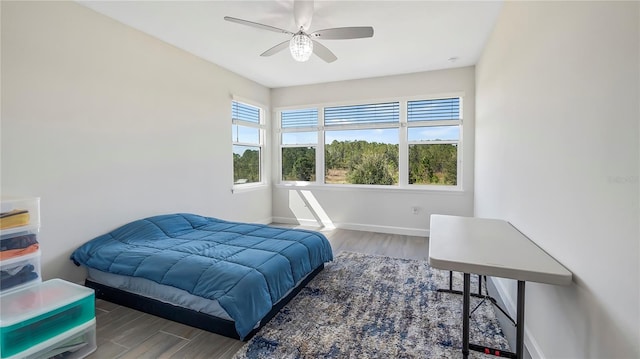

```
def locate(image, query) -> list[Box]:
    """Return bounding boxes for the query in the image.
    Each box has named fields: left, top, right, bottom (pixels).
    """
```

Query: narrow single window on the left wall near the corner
left=231, top=101, right=264, bottom=185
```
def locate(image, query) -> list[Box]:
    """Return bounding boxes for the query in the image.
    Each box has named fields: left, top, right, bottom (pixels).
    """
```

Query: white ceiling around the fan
left=78, top=0, right=502, bottom=88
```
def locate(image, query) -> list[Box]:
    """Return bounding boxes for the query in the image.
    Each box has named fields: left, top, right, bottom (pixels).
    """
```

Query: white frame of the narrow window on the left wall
left=230, top=96, right=268, bottom=193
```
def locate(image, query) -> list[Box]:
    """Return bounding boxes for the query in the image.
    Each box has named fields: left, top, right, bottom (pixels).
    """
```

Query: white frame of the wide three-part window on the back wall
left=274, top=92, right=465, bottom=192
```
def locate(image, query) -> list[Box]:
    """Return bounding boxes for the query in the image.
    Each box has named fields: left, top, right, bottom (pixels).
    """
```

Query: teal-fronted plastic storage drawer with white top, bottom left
left=0, top=279, right=95, bottom=358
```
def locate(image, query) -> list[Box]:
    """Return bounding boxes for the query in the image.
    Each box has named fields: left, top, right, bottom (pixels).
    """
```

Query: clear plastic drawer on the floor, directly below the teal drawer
left=3, top=319, right=98, bottom=359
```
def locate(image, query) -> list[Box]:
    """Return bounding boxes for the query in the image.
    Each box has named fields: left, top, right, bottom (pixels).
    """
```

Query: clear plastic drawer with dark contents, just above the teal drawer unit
left=0, top=249, right=42, bottom=296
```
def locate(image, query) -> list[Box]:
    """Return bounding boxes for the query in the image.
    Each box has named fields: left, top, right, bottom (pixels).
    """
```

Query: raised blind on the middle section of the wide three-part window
left=324, top=102, right=400, bottom=126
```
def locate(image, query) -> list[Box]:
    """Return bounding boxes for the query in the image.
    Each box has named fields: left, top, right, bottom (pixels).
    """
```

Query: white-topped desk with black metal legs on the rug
left=429, top=214, right=572, bottom=358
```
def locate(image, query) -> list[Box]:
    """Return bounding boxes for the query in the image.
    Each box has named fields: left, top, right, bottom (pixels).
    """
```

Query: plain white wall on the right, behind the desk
left=475, top=2, right=640, bottom=358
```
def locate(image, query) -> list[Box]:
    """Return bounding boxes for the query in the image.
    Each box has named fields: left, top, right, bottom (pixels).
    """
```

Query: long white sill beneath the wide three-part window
left=275, top=182, right=468, bottom=196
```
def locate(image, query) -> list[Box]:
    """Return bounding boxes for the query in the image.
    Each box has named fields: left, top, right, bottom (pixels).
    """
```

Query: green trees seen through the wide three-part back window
left=282, top=141, right=458, bottom=185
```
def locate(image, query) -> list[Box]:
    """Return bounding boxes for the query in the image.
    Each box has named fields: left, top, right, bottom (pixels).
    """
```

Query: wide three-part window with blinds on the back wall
left=280, top=97, right=462, bottom=188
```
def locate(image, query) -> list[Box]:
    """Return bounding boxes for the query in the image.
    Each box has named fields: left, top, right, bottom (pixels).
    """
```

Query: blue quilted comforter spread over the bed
left=71, top=213, right=333, bottom=339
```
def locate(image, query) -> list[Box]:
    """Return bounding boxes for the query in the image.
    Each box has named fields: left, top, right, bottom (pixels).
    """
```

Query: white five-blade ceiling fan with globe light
left=224, top=0, right=373, bottom=63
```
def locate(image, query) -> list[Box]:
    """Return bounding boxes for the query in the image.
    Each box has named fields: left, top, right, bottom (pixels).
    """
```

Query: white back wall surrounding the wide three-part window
left=271, top=67, right=475, bottom=235
